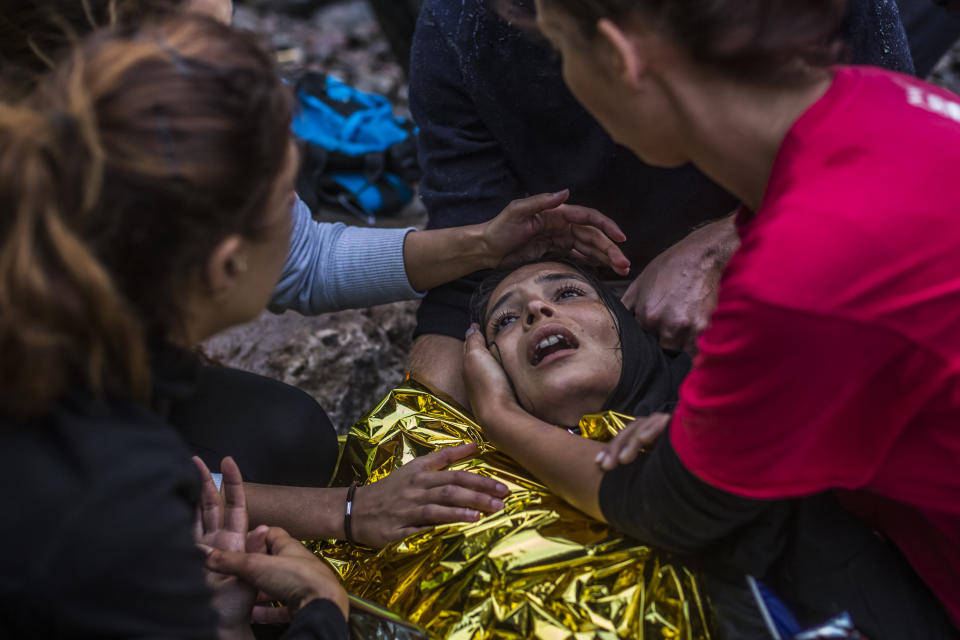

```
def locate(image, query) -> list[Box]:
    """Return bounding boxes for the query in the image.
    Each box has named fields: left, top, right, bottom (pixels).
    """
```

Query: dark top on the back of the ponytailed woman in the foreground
left=0, top=396, right=214, bottom=637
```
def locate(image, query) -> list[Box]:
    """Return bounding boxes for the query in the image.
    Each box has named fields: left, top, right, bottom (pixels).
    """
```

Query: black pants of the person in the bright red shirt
left=696, top=494, right=960, bottom=640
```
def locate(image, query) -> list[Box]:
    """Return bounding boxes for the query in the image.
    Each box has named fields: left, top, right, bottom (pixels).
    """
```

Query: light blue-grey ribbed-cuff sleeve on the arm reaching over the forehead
left=270, top=198, right=421, bottom=315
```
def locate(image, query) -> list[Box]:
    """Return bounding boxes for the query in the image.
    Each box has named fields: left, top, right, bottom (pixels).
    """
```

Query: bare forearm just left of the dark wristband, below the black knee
left=243, top=483, right=347, bottom=540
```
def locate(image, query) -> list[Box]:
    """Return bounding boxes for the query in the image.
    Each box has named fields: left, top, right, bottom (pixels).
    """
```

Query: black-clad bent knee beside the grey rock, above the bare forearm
left=169, top=366, right=338, bottom=487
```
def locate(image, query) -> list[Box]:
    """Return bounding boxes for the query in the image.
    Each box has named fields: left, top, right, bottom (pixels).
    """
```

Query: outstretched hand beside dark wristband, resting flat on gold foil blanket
left=352, top=444, right=509, bottom=548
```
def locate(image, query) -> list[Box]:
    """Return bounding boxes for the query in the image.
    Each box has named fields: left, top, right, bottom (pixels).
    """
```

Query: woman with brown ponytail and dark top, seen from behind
left=0, top=8, right=628, bottom=637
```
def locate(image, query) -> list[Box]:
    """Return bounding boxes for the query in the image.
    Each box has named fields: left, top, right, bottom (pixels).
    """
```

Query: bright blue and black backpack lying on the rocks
left=293, top=72, right=420, bottom=223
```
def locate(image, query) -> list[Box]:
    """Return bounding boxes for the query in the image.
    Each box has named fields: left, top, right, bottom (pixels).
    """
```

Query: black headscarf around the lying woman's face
left=470, top=256, right=692, bottom=418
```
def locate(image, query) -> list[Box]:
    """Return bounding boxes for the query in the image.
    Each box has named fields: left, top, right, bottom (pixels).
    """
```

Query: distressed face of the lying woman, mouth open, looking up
left=483, top=262, right=621, bottom=426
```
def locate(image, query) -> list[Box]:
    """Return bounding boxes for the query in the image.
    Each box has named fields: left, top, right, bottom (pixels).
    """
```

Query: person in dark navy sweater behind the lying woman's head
left=410, top=0, right=960, bottom=403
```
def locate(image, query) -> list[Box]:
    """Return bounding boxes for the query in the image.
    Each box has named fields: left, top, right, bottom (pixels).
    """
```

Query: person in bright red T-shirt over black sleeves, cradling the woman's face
left=465, top=0, right=960, bottom=625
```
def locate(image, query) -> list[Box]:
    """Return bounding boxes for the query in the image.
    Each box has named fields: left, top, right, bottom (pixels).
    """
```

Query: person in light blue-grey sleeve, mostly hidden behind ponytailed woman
left=0, top=0, right=626, bottom=545
